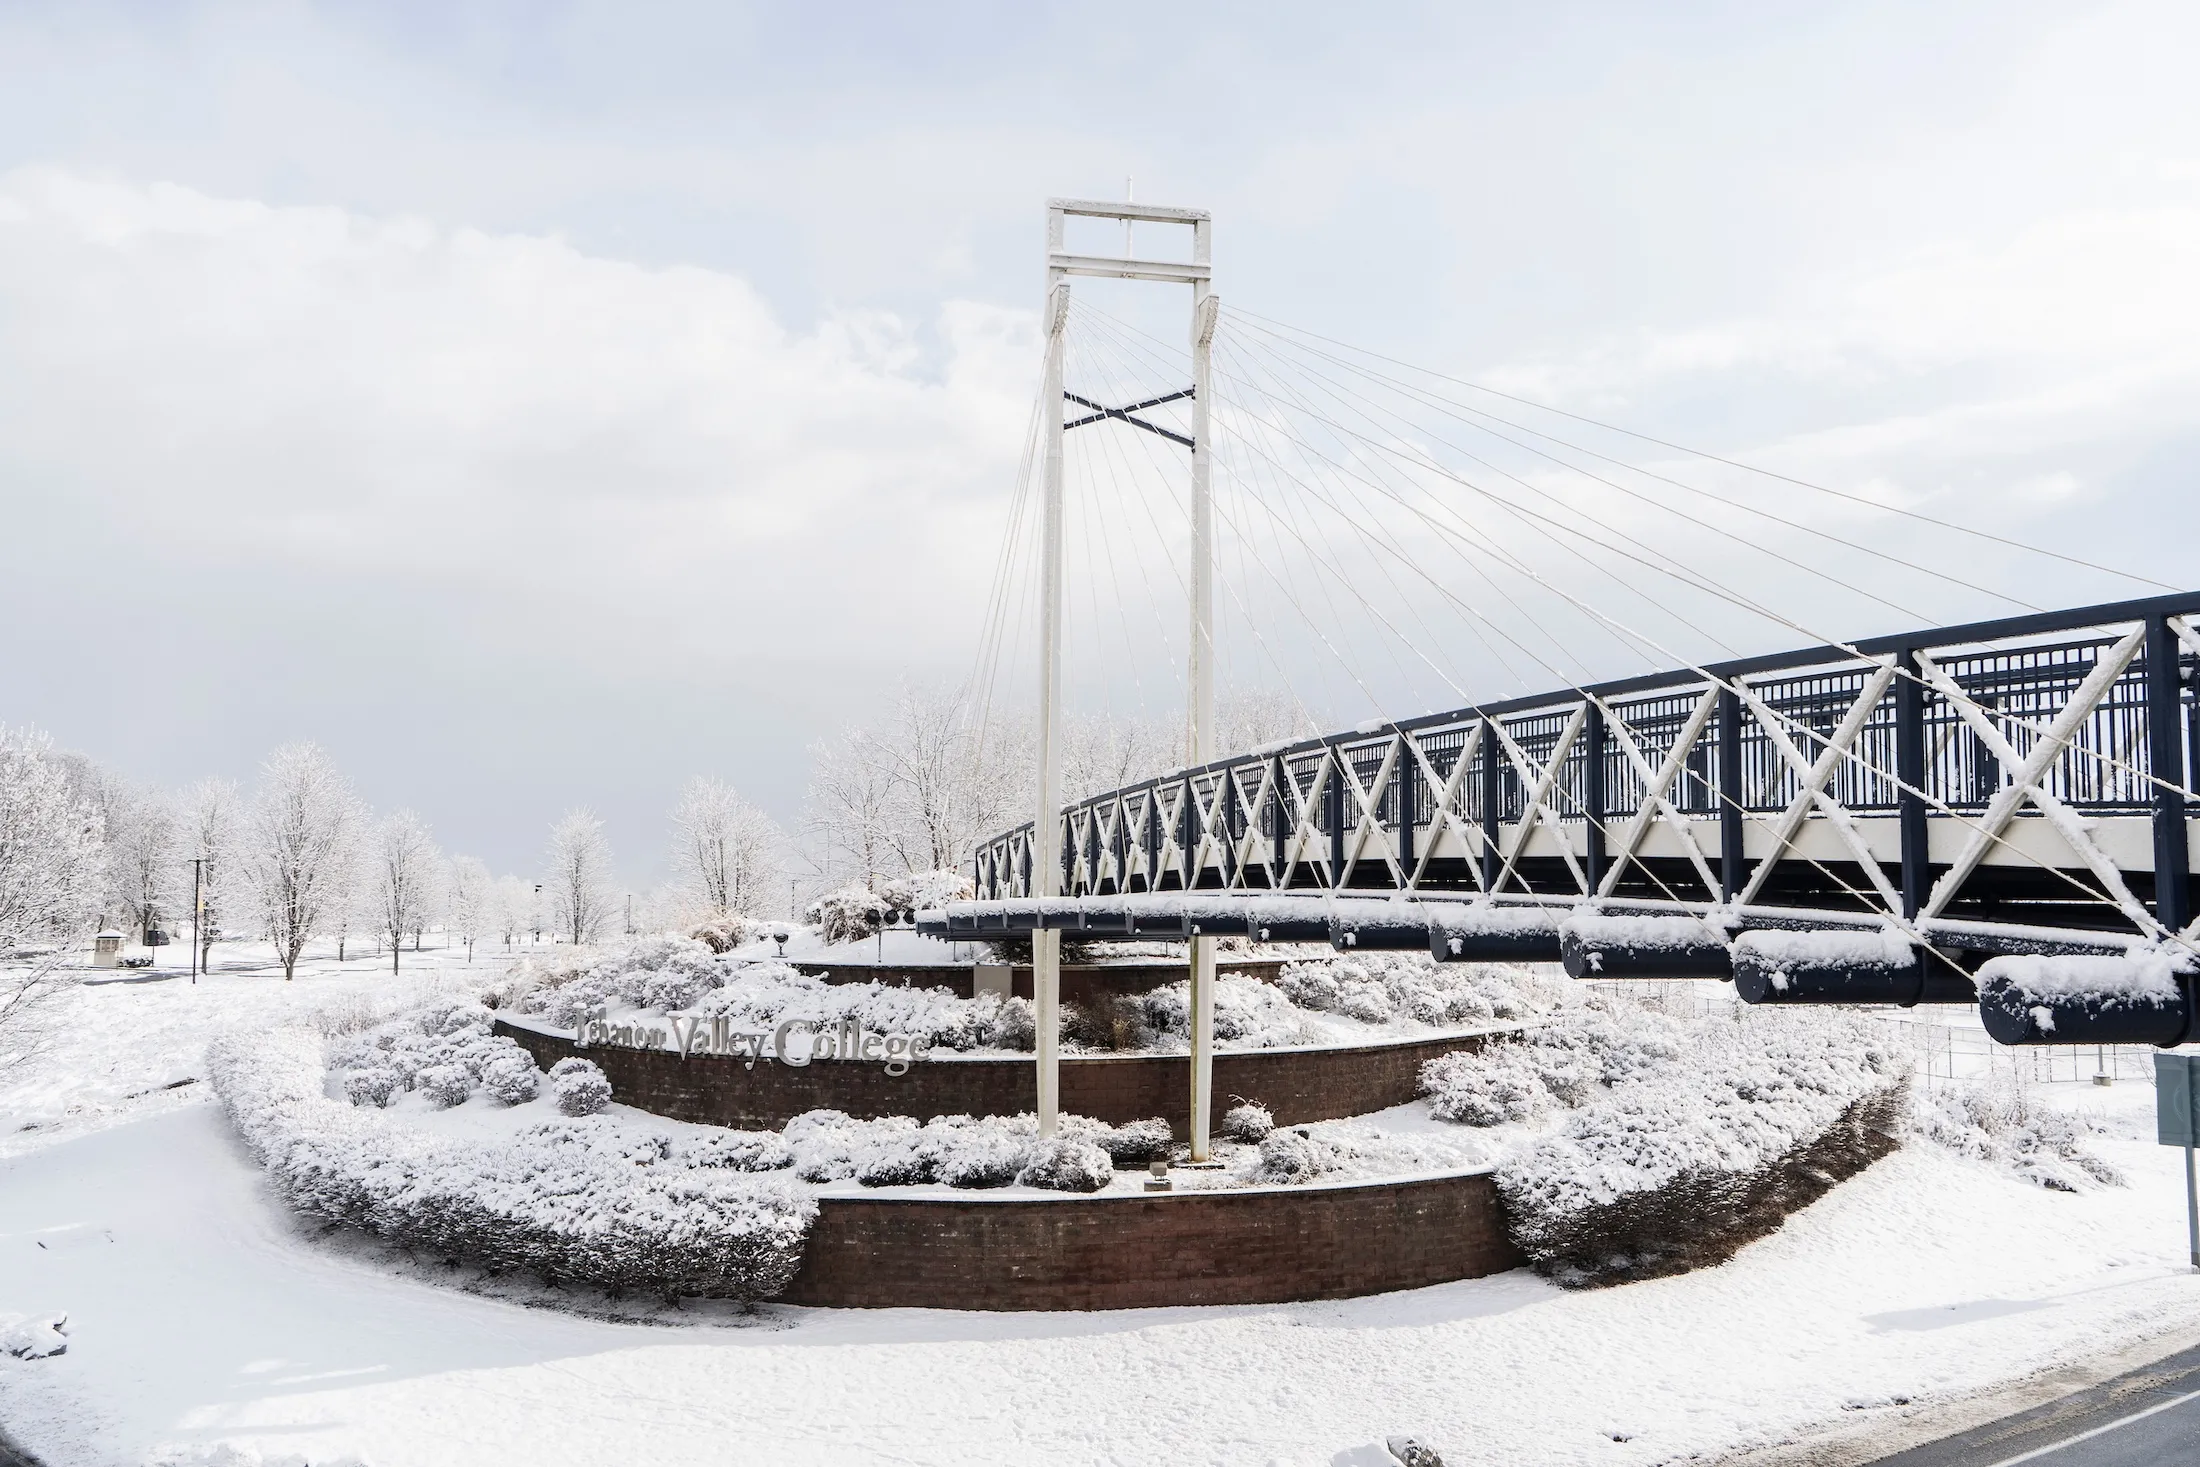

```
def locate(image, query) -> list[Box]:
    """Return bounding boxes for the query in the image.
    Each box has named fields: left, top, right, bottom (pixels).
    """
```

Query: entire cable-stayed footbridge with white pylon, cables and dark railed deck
left=937, top=200, right=2200, bottom=1155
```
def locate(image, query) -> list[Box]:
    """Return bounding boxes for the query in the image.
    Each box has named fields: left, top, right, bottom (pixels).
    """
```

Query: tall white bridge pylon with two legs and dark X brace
left=1032, top=198, right=1219, bottom=1161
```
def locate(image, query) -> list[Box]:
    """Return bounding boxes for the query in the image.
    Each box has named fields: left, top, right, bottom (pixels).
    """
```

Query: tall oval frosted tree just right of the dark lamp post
left=240, top=743, right=359, bottom=981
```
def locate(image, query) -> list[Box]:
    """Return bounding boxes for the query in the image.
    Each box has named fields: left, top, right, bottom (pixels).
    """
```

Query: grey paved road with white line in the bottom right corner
left=1872, top=1348, right=2200, bottom=1467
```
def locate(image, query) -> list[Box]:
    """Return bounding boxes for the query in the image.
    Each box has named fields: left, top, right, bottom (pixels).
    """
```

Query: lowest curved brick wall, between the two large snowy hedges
left=783, top=1172, right=1522, bottom=1309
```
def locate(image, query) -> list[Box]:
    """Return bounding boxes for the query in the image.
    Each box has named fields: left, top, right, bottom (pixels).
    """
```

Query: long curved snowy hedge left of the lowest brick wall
left=209, top=1029, right=816, bottom=1300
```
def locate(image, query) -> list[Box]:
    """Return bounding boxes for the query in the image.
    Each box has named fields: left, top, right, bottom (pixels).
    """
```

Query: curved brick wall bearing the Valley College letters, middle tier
left=497, top=1018, right=1489, bottom=1135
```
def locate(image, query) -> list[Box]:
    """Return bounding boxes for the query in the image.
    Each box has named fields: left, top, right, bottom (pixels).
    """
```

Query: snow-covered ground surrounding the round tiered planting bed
left=0, top=950, right=2200, bottom=1467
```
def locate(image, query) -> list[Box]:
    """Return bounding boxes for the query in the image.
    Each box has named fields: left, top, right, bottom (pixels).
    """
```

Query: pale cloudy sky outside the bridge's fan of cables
left=0, top=0, right=2200, bottom=880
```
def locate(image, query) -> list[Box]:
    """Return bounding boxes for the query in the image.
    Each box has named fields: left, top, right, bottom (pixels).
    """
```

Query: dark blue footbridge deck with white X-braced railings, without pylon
left=924, top=594, right=2200, bottom=1043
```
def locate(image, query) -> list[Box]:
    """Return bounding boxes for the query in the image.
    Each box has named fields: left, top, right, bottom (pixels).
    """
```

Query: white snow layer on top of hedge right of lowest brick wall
left=1496, top=1014, right=1905, bottom=1223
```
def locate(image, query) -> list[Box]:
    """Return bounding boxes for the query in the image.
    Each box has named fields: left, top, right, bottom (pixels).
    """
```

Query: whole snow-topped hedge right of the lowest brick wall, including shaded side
left=1498, top=1014, right=1907, bottom=1287
